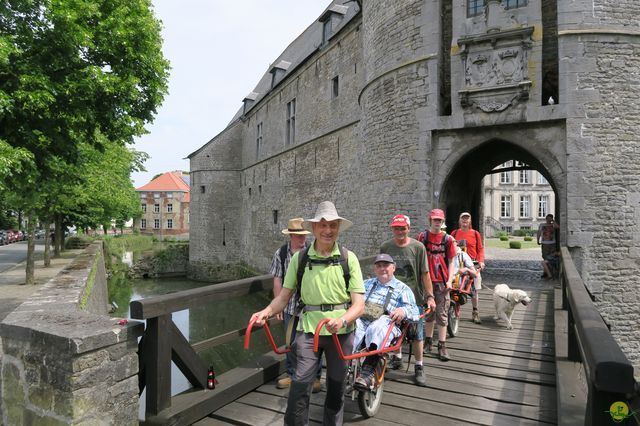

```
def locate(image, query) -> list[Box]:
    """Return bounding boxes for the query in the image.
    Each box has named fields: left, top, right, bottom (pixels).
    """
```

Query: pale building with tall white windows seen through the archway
left=482, top=161, right=555, bottom=237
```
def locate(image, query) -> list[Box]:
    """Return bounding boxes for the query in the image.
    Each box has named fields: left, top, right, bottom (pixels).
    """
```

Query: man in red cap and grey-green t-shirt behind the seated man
left=380, top=214, right=436, bottom=386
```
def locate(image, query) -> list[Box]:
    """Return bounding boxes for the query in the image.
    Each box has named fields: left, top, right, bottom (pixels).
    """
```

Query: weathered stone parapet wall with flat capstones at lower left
left=0, top=242, right=143, bottom=426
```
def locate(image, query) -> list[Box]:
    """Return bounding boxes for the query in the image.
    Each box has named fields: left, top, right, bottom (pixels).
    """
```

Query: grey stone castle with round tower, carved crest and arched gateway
left=189, top=0, right=640, bottom=366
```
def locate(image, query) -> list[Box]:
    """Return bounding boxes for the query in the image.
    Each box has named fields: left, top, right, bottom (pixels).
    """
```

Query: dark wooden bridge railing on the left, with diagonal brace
left=130, top=275, right=281, bottom=425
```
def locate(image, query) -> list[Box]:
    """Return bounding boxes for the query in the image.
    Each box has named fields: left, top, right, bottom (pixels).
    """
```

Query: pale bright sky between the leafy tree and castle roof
left=131, top=0, right=331, bottom=188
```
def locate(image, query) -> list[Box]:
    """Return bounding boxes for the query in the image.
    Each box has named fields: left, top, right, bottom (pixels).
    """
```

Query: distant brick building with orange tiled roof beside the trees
left=134, top=171, right=191, bottom=240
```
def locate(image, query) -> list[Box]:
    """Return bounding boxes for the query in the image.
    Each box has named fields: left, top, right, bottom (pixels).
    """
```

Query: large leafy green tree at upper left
left=0, top=0, right=169, bottom=281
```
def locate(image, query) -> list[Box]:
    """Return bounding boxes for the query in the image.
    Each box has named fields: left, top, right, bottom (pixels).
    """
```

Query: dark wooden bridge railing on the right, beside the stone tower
left=558, top=247, right=638, bottom=425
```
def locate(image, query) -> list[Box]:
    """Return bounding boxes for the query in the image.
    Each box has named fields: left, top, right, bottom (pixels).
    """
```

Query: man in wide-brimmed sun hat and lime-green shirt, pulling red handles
left=252, top=201, right=364, bottom=425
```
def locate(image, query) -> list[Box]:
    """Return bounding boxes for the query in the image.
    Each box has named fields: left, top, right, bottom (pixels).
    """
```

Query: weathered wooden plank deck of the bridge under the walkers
left=196, top=282, right=557, bottom=426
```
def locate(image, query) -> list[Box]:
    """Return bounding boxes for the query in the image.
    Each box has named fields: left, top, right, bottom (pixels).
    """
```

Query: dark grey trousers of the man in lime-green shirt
left=284, top=331, right=353, bottom=426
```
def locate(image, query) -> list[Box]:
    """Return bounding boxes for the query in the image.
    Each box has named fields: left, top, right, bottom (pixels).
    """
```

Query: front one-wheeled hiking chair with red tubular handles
left=244, top=308, right=430, bottom=418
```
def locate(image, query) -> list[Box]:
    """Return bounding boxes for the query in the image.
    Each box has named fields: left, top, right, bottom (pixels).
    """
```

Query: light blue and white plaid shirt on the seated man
left=364, top=277, right=420, bottom=321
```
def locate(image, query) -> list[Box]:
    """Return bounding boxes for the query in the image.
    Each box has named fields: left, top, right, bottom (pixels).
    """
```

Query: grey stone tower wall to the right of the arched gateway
left=558, top=1, right=640, bottom=368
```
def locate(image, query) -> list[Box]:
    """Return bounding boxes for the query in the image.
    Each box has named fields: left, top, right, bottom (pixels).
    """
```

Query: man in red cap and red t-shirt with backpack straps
left=417, top=209, right=456, bottom=361
